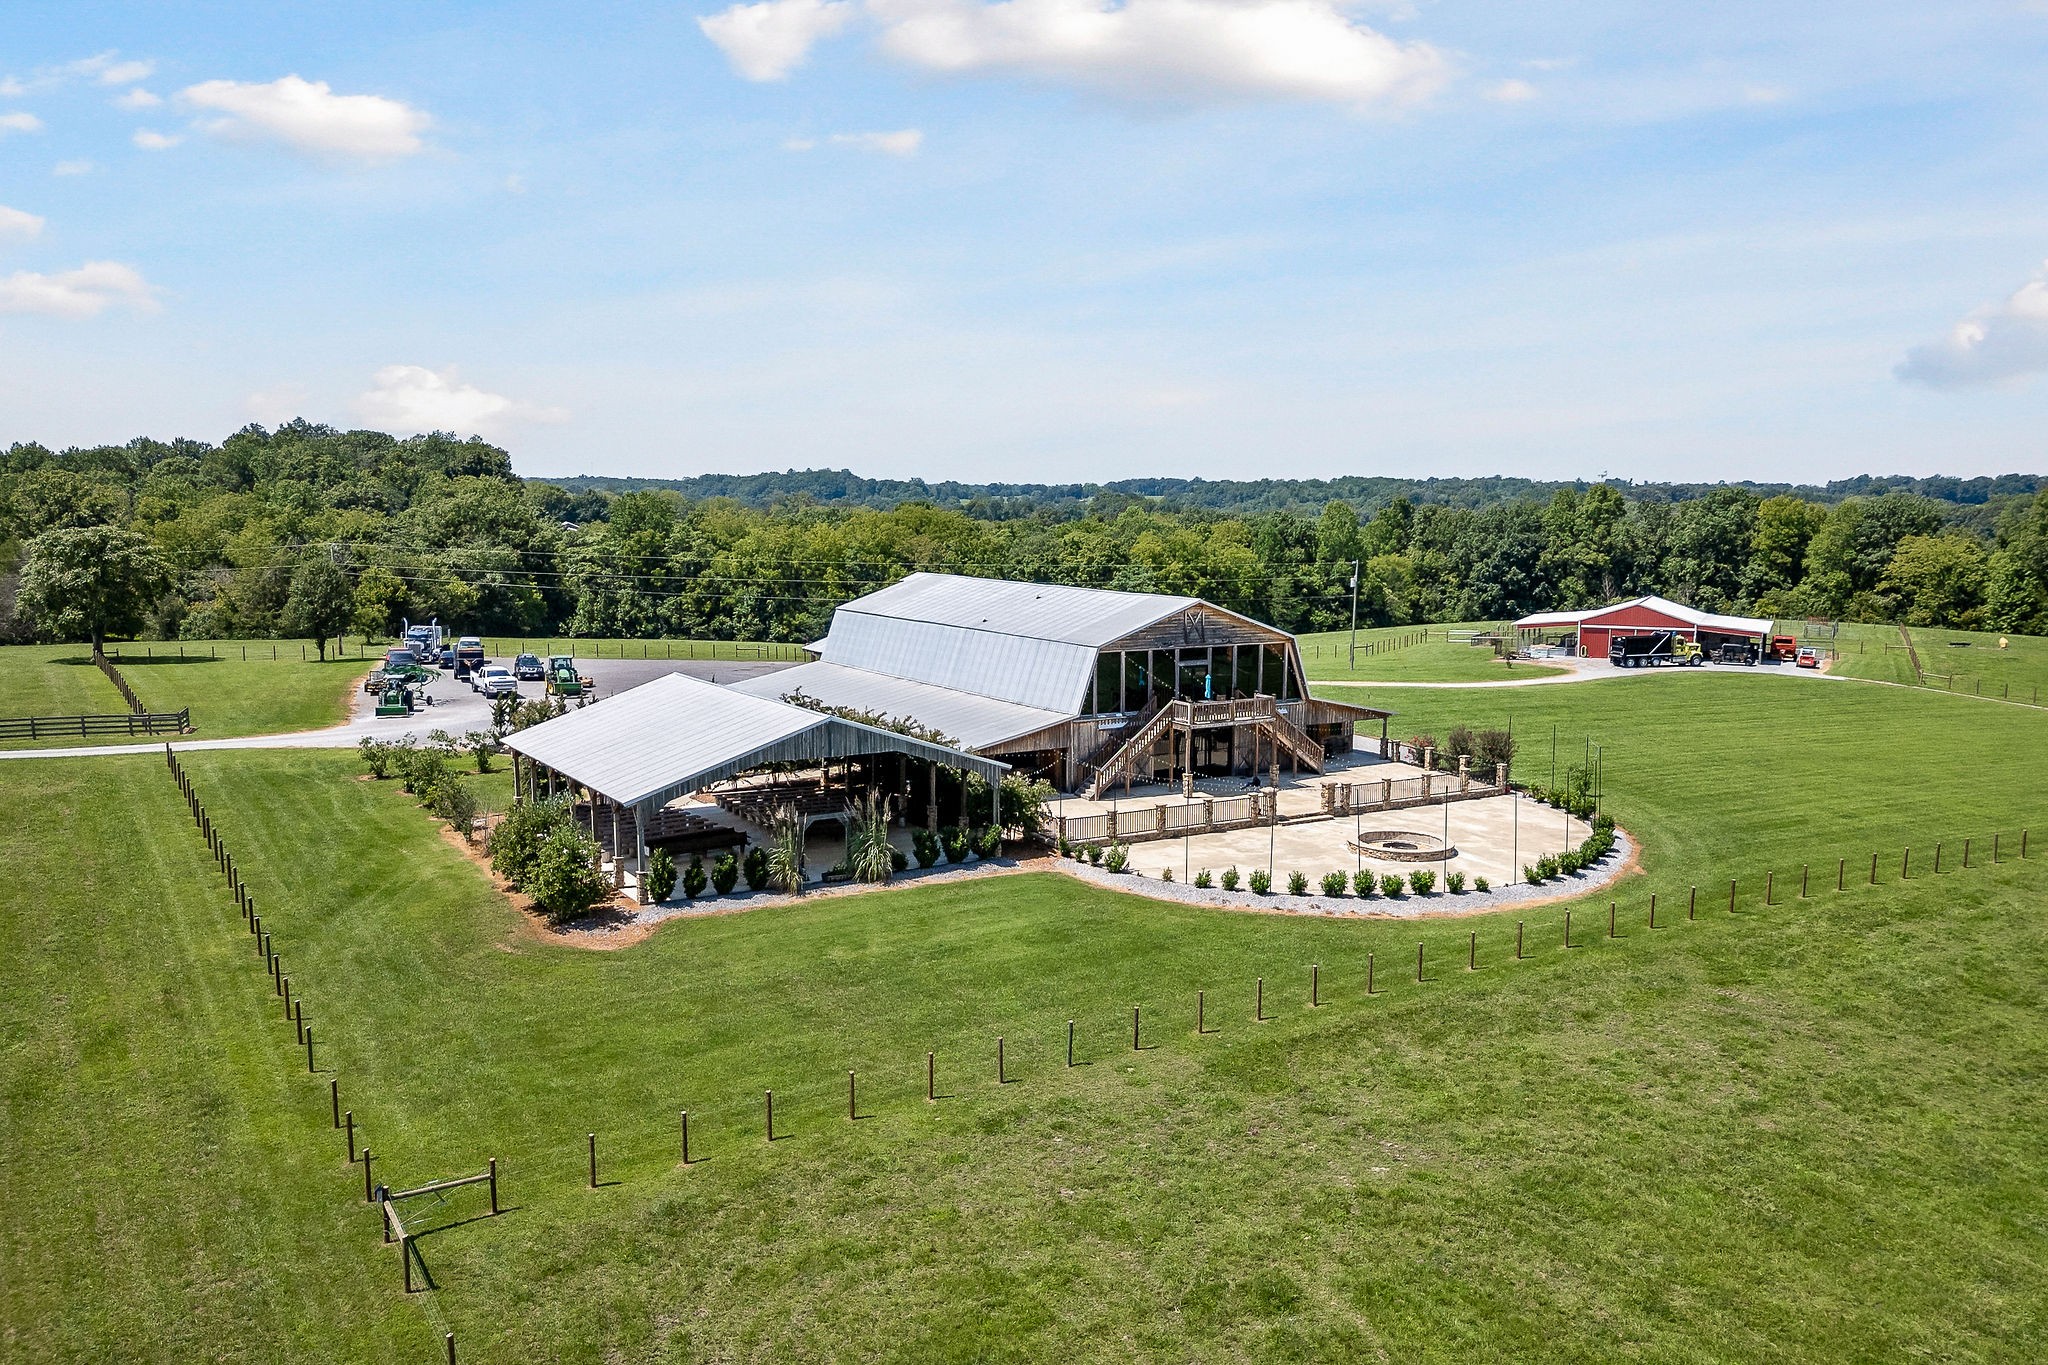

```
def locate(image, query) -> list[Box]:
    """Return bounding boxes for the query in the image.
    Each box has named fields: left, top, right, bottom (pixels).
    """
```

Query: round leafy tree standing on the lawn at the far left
left=16, top=526, right=170, bottom=651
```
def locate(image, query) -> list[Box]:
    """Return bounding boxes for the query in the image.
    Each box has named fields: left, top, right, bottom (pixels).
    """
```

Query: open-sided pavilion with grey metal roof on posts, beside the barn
left=506, top=673, right=1010, bottom=896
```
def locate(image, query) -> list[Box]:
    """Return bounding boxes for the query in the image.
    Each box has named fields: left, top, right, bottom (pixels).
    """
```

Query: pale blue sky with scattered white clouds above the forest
left=0, top=0, right=2048, bottom=481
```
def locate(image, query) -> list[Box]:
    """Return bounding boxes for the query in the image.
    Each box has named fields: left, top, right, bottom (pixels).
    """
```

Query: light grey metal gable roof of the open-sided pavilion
left=506, top=673, right=1008, bottom=806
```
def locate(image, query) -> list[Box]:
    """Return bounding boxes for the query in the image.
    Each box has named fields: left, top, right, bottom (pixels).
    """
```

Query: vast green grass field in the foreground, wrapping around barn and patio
left=0, top=673, right=2048, bottom=1361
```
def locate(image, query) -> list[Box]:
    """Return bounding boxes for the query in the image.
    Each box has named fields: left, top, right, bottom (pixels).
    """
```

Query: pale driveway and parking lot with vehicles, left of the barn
left=0, top=659, right=793, bottom=759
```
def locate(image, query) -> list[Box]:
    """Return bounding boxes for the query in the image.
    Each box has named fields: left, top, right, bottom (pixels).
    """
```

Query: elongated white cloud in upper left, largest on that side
left=178, top=76, right=430, bottom=162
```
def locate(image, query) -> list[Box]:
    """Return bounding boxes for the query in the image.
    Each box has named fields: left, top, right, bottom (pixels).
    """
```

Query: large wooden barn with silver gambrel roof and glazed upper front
left=731, top=573, right=1389, bottom=794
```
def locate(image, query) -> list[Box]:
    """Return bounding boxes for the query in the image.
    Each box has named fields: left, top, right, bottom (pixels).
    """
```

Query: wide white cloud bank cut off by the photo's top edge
left=698, top=0, right=1448, bottom=104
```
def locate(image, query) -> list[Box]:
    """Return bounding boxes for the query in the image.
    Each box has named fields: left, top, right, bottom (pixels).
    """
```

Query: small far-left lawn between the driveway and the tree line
left=0, top=641, right=373, bottom=747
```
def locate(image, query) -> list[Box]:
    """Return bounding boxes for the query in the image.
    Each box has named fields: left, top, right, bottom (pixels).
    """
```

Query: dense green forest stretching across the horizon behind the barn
left=0, top=422, right=2048, bottom=641
